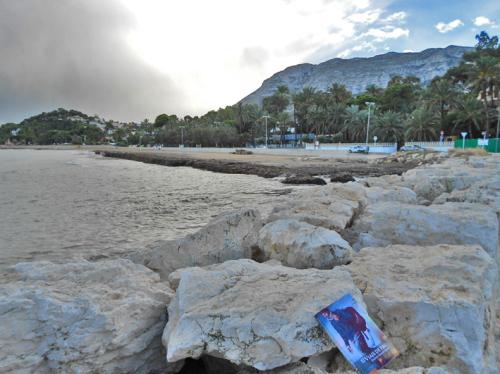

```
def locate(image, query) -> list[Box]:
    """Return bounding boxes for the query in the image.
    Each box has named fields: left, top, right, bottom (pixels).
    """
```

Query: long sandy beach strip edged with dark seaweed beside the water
left=0, top=145, right=422, bottom=184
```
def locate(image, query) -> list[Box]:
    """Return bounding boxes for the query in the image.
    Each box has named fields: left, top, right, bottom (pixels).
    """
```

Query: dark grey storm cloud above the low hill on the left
left=0, top=0, right=183, bottom=123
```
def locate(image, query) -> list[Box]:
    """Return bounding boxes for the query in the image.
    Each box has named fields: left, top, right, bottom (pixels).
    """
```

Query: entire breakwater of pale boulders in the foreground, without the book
left=0, top=152, right=500, bottom=374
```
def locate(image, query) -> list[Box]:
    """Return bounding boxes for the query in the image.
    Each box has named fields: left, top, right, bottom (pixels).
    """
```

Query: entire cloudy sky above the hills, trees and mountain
left=0, top=0, right=500, bottom=123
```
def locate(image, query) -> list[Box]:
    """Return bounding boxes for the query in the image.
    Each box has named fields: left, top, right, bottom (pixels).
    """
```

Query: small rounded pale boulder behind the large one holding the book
left=259, top=219, right=352, bottom=269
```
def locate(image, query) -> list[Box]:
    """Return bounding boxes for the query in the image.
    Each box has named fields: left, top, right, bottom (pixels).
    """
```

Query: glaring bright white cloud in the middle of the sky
left=120, top=0, right=378, bottom=114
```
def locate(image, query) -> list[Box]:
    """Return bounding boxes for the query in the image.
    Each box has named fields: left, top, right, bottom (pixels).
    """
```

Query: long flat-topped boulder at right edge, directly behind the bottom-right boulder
left=352, top=202, right=498, bottom=258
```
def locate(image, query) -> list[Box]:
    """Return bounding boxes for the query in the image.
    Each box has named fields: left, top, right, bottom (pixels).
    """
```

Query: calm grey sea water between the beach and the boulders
left=0, top=150, right=289, bottom=268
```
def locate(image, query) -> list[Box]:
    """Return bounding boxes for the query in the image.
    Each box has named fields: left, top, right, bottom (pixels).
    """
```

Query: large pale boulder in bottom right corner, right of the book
left=343, top=245, right=497, bottom=374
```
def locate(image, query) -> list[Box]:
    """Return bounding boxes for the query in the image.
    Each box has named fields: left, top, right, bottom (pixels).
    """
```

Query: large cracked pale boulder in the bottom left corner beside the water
left=0, top=260, right=173, bottom=373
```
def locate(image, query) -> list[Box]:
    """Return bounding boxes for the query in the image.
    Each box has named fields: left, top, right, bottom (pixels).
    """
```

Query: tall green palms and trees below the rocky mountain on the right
left=263, top=32, right=500, bottom=142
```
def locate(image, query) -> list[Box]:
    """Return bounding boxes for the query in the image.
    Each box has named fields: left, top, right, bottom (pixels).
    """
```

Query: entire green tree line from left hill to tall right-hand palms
left=0, top=31, right=500, bottom=146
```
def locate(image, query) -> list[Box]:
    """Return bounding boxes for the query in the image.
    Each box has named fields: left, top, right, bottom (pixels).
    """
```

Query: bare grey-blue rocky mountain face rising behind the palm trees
left=242, top=45, right=473, bottom=105
